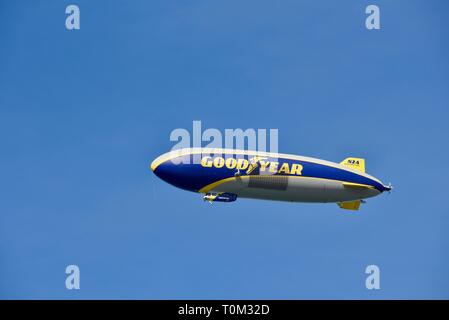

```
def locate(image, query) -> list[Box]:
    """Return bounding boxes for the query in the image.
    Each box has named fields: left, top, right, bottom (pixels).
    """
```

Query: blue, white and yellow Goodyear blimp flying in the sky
left=150, top=148, right=392, bottom=210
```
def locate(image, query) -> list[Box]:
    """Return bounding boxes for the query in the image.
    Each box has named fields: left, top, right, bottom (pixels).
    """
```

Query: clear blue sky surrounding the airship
left=0, top=0, right=449, bottom=299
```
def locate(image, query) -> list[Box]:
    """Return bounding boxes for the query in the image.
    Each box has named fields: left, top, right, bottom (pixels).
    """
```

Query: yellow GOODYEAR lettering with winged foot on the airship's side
left=201, top=156, right=303, bottom=176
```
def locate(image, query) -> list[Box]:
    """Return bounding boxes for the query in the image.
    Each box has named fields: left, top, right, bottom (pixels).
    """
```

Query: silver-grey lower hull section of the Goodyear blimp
left=208, top=176, right=380, bottom=203
